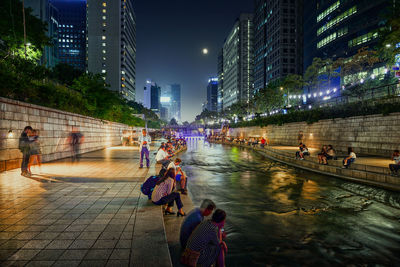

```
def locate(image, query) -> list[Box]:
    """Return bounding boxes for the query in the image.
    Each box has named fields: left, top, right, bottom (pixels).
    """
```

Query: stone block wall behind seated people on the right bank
left=220, top=113, right=400, bottom=157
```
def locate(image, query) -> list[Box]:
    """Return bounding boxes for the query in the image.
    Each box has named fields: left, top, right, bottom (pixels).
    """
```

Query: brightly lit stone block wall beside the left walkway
left=0, top=97, right=144, bottom=171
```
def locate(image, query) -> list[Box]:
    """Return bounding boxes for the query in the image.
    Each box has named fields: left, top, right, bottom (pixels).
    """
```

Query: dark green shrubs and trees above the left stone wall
left=0, top=56, right=159, bottom=128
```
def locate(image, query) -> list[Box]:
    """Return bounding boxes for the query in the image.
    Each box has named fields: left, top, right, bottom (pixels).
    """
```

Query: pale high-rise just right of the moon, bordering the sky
left=223, top=14, right=254, bottom=109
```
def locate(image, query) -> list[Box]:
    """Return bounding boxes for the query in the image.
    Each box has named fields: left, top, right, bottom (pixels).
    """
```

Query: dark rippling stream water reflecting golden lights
left=181, top=140, right=400, bottom=266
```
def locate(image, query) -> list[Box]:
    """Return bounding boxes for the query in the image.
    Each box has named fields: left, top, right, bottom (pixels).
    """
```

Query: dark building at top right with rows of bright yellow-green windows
left=304, top=0, right=392, bottom=69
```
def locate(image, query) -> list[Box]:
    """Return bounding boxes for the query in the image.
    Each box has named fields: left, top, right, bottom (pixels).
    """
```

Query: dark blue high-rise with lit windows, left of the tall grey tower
left=53, top=0, right=86, bottom=71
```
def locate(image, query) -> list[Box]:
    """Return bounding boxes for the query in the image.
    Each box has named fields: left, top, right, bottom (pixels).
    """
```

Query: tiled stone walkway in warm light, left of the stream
left=0, top=147, right=170, bottom=267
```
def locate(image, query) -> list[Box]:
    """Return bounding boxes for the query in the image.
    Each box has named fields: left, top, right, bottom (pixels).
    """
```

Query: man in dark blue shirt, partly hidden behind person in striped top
left=179, top=199, right=216, bottom=249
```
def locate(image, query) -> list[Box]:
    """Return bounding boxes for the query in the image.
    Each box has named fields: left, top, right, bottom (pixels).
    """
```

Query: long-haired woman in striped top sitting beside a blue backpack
left=151, top=169, right=186, bottom=217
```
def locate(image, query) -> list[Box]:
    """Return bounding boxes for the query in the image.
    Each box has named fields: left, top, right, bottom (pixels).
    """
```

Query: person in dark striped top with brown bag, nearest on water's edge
left=181, top=209, right=228, bottom=267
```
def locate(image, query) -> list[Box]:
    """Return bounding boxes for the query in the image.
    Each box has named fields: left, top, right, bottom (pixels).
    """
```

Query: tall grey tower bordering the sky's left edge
left=87, top=0, right=136, bottom=100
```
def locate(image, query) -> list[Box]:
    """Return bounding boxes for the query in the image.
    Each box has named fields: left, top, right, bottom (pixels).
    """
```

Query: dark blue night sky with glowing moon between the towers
left=134, top=0, right=254, bottom=122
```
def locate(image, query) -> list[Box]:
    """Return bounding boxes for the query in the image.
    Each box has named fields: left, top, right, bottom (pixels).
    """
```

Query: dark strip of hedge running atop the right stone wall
left=209, top=97, right=400, bottom=129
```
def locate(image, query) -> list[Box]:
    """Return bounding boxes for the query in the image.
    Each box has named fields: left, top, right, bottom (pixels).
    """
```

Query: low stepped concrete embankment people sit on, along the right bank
left=210, top=141, right=400, bottom=191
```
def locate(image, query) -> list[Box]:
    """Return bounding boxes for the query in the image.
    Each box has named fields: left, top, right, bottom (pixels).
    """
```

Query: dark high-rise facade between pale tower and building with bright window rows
left=254, top=0, right=303, bottom=92
